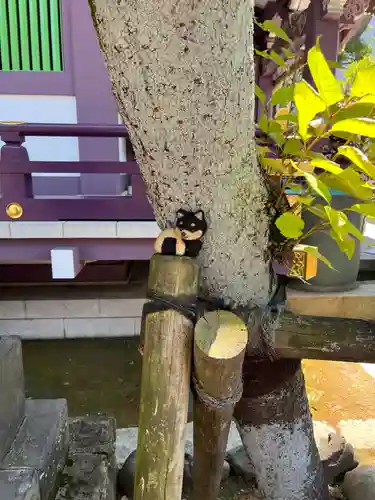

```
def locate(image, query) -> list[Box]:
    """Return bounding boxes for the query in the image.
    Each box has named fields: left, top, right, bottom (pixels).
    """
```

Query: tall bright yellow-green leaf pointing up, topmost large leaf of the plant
left=307, top=39, right=344, bottom=106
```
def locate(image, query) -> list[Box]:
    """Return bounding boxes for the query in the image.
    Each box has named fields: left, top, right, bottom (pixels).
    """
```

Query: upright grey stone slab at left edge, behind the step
left=0, top=337, right=25, bottom=462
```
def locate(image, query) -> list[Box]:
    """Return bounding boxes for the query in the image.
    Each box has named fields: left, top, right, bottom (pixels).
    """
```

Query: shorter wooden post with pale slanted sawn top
left=193, top=311, right=248, bottom=500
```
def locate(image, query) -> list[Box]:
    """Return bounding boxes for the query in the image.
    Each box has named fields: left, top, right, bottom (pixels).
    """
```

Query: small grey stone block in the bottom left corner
left=0, top=469, right=40, bottom=500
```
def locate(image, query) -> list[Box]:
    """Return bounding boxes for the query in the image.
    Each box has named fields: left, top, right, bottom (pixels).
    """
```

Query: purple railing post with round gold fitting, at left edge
left=0, top=131, right=32, bottom=219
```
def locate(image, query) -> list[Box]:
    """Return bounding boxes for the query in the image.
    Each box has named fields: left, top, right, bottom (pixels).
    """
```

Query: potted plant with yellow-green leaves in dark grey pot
left=256, top=23, right=375, bottom=291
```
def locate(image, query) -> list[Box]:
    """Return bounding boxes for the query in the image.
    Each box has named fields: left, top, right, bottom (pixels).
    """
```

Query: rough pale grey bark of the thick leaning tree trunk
left=88, top=0, right=325, bottom=500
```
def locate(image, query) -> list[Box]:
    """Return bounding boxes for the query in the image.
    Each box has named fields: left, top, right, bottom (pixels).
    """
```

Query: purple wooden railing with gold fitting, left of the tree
left=0, top=123, right=154, bottom=221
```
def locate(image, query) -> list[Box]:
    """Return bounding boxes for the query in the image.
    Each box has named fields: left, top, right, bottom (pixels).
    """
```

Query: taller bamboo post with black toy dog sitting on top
left=134, top=254, right=199, bottom=500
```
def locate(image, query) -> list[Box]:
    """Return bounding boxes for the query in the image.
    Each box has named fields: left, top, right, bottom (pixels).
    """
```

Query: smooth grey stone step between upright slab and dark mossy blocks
left=0, top=399, right=69, bottom=500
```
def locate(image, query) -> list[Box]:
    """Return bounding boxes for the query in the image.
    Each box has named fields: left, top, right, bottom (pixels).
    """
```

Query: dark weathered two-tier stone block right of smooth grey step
left=55, top=417, right=116, bottom=500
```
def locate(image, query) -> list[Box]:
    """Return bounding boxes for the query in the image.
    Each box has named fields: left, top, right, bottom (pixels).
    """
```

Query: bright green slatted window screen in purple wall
left=0, top=0, right=63, bottom=71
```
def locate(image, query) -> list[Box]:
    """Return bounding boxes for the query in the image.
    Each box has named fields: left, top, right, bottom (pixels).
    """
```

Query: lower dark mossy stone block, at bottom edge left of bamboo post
left=56, top=452, right=116, bottom=500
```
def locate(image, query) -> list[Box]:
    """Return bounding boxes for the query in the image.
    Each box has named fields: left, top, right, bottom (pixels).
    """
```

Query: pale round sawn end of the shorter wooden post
left=195, top=310, right=248, bottom=359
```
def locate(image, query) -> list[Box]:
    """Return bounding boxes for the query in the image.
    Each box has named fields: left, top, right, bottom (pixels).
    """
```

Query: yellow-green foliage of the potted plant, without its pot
left=256, top=22, right=375, bottom=265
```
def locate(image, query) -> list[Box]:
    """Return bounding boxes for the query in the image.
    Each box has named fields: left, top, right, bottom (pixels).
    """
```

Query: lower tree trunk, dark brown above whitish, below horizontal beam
left=235, top=358, right=328, bottom=500
